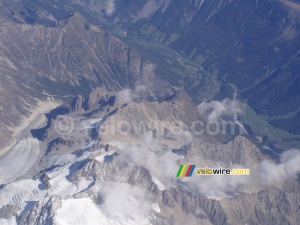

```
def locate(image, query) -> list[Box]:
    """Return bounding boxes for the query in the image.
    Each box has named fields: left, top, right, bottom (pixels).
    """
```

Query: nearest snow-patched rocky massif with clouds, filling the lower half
left=0, top=88, right=300, bottom=225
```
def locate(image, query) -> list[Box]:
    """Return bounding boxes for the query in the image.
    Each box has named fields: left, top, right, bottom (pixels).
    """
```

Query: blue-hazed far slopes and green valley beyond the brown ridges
left=2, top=0, right=300, bottom=152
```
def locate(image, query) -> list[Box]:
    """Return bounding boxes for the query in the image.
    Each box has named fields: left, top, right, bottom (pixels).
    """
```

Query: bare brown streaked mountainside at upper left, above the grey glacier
left=0, top=14, right=170, bottom=149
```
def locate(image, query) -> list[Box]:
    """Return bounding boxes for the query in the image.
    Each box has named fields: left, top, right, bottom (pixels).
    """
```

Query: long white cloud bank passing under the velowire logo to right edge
left=109, top=115, right=300, bottom=198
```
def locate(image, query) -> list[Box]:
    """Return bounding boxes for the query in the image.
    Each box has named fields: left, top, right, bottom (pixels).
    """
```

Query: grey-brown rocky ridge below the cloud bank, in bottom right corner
left=152, top=186, right=299, bottom=225
